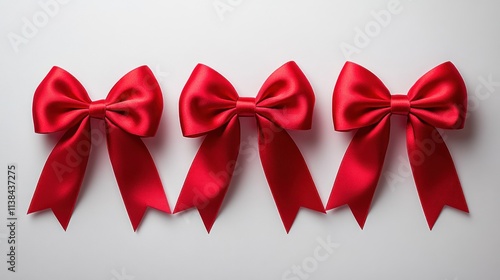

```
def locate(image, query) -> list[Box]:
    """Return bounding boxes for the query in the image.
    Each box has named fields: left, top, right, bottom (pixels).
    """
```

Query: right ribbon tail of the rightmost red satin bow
left=406, top=118, right=469, bottom=229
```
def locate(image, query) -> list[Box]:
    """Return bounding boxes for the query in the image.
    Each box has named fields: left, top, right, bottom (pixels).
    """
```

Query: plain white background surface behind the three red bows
left=0, top=0, right=500, bottom=280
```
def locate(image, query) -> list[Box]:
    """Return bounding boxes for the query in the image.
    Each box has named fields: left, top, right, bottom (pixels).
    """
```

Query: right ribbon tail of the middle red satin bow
left=257, top=116, right=325, bottom=232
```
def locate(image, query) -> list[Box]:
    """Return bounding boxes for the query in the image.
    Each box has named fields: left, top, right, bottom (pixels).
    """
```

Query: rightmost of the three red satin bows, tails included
left=326, top=62, right=469, bottom=229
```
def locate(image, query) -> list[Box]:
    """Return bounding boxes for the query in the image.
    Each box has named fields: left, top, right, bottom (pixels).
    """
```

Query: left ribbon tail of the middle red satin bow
left=174, top=117, right=240, bottom=232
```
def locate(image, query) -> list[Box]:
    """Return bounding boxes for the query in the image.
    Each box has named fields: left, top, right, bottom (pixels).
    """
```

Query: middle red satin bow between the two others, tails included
left=174, top=62, right=324, bottom=232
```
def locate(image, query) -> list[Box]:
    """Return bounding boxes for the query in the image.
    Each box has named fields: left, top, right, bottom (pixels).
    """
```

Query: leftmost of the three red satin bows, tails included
left=28, top=66, right=170, bottom=230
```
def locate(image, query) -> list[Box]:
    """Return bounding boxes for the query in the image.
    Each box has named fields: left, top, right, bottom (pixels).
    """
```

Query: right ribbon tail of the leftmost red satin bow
left=107, top=122, right=170, bottom=231
